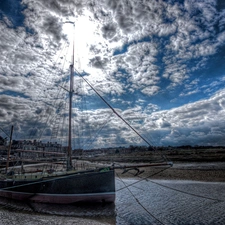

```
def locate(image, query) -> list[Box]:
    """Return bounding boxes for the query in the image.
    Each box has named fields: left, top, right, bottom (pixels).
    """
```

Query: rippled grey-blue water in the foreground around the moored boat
left=0, top=178, right=225, bottom=225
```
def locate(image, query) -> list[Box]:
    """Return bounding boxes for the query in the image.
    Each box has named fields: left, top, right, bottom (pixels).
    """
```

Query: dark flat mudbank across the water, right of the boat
left=83, top=148, right=225, bottom=182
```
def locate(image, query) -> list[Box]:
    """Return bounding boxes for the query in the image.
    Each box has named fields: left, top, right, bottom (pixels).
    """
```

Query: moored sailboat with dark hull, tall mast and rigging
left=0, top=24, right=171, bottom=204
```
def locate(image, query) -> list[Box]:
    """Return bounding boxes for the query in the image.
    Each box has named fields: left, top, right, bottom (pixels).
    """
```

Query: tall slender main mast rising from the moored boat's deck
left=67, top=24, right=75, bottom=170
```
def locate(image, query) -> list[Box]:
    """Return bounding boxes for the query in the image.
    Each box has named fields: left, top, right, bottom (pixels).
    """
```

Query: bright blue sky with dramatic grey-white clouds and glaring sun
left=0, top=0, right=225, bottom=148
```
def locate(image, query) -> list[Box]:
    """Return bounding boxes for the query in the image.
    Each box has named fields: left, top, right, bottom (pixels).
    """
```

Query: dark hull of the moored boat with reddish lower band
left=0, top=170, right=115, bottom=204
